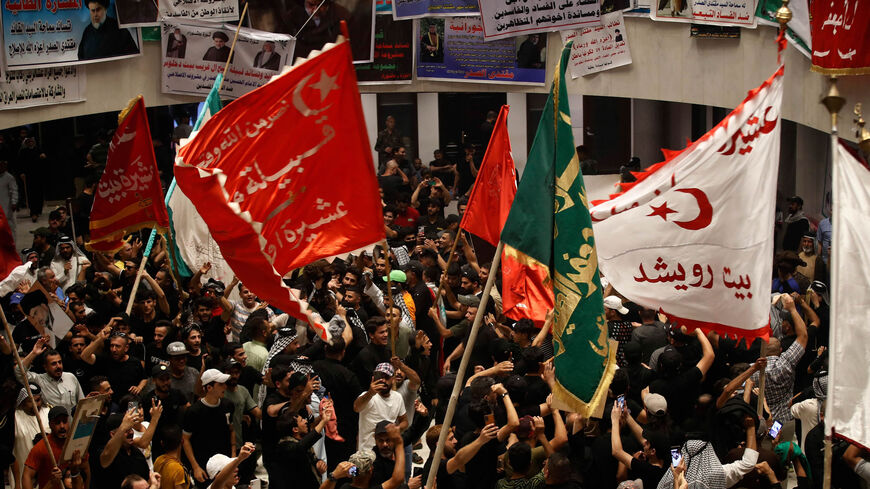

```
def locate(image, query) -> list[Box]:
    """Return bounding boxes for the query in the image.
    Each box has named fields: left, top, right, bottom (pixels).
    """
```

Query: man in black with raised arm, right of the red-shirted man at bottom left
left=94, top=409, right=152, bottom=487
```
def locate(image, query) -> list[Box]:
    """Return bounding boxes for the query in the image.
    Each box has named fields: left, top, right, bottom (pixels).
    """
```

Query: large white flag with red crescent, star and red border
left=590, top=66, right=783, bottom=338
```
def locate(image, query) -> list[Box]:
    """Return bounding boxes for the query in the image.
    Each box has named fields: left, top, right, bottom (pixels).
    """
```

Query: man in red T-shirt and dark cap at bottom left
left=21, top=406, right=91, bottom=489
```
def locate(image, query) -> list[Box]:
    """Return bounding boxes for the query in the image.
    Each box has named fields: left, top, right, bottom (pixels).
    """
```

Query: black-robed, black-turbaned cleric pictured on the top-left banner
left=79, top=0, right=139, bottom=60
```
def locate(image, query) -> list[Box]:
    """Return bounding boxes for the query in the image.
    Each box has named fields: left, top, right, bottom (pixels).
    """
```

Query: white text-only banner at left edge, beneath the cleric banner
left=0, top=66, right=85, bottom=110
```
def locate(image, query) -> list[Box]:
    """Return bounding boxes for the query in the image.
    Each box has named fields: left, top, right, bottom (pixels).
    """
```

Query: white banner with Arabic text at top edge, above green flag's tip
left=480, top=0, right=600, bottom=41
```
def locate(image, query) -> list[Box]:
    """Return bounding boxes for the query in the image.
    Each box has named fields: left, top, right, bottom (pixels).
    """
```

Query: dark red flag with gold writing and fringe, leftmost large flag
left=85, top=95, right=169, bottom=253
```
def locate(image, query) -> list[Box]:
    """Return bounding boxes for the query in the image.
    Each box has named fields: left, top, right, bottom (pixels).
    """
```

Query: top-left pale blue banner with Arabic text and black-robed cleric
left=3, top=0, right=142, bottom=70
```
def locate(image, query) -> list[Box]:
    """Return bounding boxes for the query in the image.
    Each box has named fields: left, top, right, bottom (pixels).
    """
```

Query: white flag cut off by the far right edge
left=825, top=140, right=870, bottom=447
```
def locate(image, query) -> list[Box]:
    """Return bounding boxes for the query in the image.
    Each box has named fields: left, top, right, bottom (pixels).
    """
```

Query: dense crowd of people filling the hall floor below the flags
left=0, top=117, right=870, bottom=489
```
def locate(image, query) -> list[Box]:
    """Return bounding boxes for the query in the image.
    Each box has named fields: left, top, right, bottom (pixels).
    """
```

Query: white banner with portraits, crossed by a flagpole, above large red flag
left=160, top=21, right=294, bottom=98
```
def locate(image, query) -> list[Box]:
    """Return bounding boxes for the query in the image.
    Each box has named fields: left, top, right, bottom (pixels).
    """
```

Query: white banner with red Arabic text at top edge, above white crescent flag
left=650, top=0, right=757, bottom=28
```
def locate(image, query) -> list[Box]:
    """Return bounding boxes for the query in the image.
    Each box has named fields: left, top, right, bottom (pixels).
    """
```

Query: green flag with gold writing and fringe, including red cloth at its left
left=501, top=42, right=616, bottom=417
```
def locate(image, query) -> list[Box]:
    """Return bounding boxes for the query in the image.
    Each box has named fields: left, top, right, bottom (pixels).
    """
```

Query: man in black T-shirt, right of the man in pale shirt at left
left=82, top=324, right=148, bottom=402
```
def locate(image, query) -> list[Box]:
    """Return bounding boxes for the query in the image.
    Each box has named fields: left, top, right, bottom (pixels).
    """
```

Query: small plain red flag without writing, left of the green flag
left=459, top=105, right=517, bottom=246
